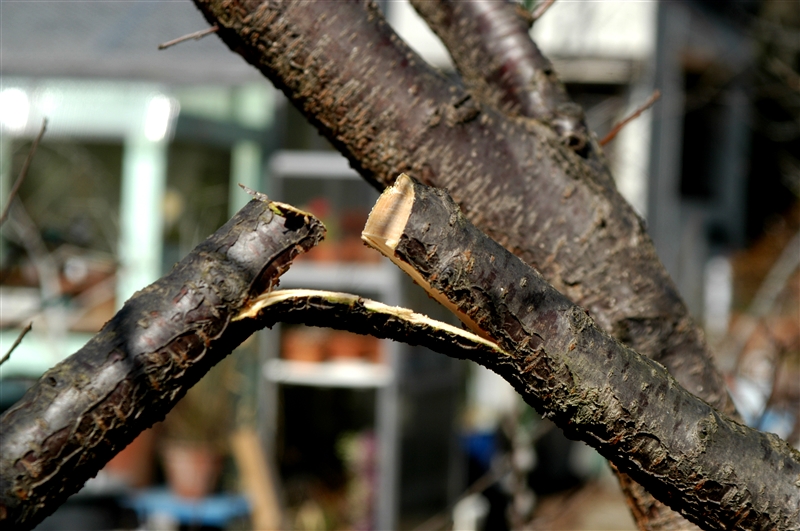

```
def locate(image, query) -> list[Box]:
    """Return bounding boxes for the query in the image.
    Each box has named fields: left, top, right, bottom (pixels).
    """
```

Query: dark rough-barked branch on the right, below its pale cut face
left=372, top=177, right=800, bottom=530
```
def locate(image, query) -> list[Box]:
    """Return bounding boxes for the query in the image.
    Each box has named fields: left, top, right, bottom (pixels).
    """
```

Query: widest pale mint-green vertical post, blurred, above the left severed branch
left=117, top=137, right=167, bottom=307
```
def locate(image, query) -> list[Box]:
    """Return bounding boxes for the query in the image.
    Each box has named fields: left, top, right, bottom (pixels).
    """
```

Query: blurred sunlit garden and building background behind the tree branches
left=0, top=0, right=800, bottom=531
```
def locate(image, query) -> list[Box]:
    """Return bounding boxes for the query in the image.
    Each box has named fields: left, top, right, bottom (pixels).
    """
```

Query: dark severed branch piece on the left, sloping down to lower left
left=0, top=199, right=324, bottom=529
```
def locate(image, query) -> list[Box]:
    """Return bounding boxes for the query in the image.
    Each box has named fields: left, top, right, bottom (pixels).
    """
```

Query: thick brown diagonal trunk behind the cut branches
left=195, top=0, right=732, bottom=422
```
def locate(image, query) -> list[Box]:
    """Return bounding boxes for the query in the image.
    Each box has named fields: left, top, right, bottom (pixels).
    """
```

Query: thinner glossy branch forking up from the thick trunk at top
left=411, top=0, right=597, bottom=156
